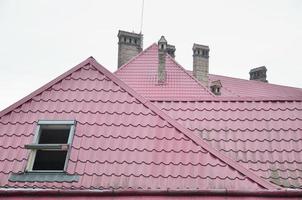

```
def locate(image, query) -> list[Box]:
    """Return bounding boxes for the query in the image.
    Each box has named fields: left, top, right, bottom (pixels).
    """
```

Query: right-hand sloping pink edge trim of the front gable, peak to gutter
left=87, top=59, right=279, bottom=190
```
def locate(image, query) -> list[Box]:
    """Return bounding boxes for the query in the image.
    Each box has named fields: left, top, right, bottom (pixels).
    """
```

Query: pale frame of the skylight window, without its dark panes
left=25, top=120, right=76, bottom=172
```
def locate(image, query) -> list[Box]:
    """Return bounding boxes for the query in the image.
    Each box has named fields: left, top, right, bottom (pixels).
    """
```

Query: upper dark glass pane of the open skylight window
left=39, top=129, right=70, bottom=144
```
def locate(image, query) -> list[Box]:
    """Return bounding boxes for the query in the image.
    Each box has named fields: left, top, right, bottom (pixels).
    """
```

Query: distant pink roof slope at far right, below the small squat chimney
left=209, top=72, right=302, bottom=100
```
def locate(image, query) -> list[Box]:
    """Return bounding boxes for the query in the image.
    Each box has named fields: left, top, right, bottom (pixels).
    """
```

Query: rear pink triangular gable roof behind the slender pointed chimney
left=115, top=44, right=213, bottom=101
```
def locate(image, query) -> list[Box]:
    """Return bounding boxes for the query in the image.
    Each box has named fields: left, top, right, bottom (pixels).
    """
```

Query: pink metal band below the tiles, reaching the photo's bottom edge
left=0, top=190, right=302, bottom=200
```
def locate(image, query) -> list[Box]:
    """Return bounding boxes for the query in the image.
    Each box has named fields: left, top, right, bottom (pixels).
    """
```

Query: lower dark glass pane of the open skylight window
left=33, top=150, right=67, bottom=170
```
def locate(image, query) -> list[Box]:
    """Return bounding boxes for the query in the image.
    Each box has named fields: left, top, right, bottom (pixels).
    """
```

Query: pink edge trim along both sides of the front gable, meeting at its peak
left=0, top=57, right=279, bottom=190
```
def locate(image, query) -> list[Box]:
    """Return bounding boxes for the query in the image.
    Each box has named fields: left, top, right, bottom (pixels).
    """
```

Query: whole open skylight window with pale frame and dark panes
left=25, top=120, right=75, bottom=172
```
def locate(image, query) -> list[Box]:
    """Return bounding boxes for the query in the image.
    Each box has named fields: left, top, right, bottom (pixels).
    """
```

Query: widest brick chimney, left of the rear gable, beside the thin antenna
left=117, top=30, right=143, bottom=68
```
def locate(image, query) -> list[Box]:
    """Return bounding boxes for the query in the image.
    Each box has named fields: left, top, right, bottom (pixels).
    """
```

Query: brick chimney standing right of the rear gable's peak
left=193, top=44, right=210, bottom=86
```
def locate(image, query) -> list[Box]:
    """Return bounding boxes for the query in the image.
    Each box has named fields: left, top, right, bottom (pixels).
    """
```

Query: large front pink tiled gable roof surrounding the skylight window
left=0, top=58, right=276, bottom=190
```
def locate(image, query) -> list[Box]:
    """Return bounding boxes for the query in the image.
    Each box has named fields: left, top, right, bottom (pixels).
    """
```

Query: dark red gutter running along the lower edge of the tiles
left=0, top=189, right=302, bottom=197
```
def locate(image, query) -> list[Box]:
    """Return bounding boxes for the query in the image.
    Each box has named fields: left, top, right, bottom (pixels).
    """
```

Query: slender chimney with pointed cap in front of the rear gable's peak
left=157, top=36, right=168, bottom=84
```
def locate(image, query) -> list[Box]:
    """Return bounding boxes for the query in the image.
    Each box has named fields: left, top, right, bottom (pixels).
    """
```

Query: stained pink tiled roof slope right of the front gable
left=154, top=99, right=302, bottom=188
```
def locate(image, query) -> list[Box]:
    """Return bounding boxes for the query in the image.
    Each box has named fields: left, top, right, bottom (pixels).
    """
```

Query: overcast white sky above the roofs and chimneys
left=0, top=0, right=302, bottom=110
